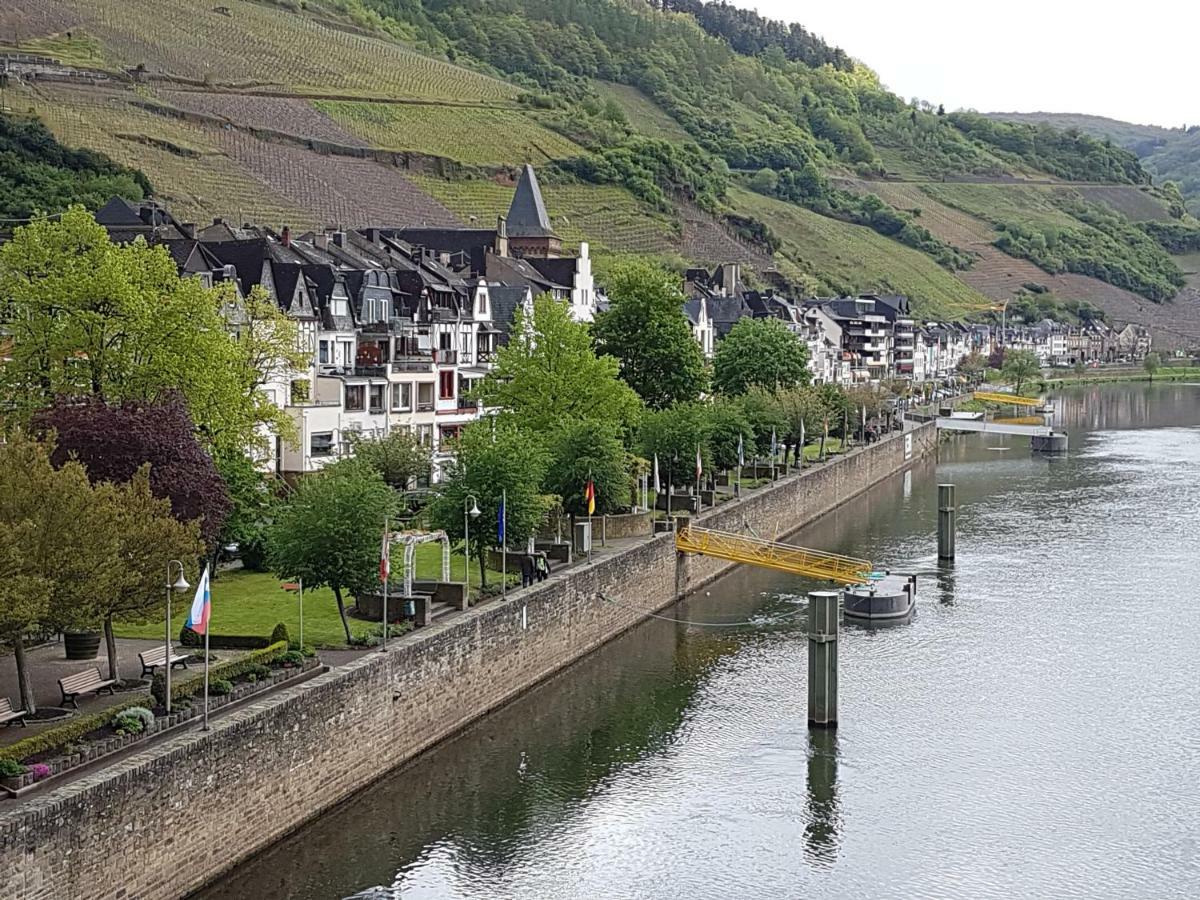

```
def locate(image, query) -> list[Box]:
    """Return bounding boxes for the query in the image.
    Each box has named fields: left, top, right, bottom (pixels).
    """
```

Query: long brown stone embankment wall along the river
left=0, top=426, right=936, bottom=900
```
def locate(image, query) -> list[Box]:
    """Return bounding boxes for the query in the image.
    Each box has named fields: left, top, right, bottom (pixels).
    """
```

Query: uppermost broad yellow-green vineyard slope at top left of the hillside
left=62, top=0, right=517, bottom=100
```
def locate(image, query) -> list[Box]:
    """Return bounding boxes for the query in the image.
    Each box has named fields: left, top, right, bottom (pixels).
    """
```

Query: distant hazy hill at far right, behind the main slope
left=990, top=113, right=1200, bottom=214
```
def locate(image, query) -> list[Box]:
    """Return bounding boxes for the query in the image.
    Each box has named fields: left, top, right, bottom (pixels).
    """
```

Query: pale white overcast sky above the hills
left=733, top=0, right=1200, bottom=126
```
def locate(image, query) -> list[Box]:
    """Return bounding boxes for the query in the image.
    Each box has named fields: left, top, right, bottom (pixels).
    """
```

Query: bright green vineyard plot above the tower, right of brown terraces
left=313, top=101, right=583, bottom=166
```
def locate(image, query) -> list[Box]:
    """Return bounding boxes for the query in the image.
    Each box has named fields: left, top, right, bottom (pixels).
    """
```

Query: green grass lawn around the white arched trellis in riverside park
left=116, top=544, right=512, bottom=647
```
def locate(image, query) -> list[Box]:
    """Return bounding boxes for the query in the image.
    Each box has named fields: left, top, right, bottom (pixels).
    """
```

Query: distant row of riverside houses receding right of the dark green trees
left=684, top=264, right=1151, bottom=384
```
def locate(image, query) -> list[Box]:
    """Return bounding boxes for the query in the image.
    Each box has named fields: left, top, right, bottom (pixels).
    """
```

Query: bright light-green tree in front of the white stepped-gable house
left=478, top=294, right=642, bottom=436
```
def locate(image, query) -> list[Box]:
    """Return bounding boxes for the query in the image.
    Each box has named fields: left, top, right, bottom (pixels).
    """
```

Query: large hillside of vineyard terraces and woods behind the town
left=9, top=0, right=1200, bottom=331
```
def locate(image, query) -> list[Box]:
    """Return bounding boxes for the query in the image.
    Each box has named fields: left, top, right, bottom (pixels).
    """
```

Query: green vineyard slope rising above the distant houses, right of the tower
left=731, top=188, right=988, bottom=319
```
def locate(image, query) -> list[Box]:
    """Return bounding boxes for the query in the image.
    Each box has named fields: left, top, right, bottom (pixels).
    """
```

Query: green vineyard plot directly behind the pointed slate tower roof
left=412, top=175, right=679, bottom=253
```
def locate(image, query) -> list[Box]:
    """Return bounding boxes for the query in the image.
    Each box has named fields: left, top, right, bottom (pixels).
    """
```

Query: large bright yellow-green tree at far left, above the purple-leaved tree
left=0, top=208, right=302, bottom=458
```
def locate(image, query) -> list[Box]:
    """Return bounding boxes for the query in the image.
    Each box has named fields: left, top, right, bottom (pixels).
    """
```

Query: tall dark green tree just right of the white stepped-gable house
left=592, top=262, right=708, bottom=409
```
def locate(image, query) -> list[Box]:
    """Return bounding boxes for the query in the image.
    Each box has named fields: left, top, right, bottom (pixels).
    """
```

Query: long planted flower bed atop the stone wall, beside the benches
left=0, top=643, right=320, bottom=796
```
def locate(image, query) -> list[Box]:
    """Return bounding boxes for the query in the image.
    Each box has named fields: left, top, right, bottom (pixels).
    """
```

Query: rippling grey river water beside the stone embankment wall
left=202, top=385, right=1200, bottom=900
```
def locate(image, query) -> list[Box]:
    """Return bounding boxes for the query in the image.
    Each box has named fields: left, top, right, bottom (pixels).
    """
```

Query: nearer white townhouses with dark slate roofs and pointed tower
left=97, top=166, right=596, bottom=480
